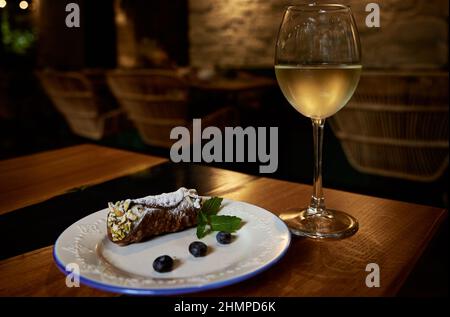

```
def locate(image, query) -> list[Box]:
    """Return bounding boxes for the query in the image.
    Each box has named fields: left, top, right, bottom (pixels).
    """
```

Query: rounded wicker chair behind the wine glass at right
left=330, top=72, right=449, bottom=182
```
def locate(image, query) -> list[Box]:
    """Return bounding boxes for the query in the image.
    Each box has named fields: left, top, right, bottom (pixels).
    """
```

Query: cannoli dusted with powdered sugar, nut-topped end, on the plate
left=107, top=187, right=201, bottom=245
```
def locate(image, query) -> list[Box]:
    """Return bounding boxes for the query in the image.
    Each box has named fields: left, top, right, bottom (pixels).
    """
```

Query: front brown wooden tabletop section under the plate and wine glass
left=0, top=144, right=447, bottom=296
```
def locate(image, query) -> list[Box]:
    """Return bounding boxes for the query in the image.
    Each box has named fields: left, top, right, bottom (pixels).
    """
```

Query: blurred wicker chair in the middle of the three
left=107, top=70, right=237, bottom=148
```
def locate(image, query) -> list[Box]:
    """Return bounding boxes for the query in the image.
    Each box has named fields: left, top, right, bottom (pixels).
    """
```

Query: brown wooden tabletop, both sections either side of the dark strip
left=0, top=145, right=447, bottom=296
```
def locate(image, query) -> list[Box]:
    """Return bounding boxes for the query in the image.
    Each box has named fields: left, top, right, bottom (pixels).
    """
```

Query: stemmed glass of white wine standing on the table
left=275, top=3, right=361, bottom=239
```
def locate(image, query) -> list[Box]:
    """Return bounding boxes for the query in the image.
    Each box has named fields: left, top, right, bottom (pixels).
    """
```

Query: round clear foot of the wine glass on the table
left=280, top=208, right=358, bottom=239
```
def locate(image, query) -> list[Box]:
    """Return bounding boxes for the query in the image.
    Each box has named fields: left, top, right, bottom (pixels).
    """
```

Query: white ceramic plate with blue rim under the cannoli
left=53, top=199, right=291, bottom=295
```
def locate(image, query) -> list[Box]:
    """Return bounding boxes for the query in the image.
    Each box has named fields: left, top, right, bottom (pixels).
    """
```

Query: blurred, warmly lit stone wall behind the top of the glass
left=189, top=0, right=449, bottom=69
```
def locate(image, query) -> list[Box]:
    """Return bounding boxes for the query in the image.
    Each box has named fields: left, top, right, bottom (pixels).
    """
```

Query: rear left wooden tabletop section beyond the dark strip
left=0, top=144, right=167, bottom=215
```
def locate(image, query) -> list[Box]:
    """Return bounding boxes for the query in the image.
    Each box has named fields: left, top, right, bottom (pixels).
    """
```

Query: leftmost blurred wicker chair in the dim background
left=37, top=70, right=125, bottom=140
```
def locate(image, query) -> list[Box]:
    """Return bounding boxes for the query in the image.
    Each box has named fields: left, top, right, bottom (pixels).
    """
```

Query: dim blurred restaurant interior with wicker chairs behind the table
left=0, top=0, right=449, bottom=207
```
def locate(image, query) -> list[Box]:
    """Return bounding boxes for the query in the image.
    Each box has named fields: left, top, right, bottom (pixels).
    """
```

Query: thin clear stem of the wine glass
left=308, top=119, right=326, bottom=214
